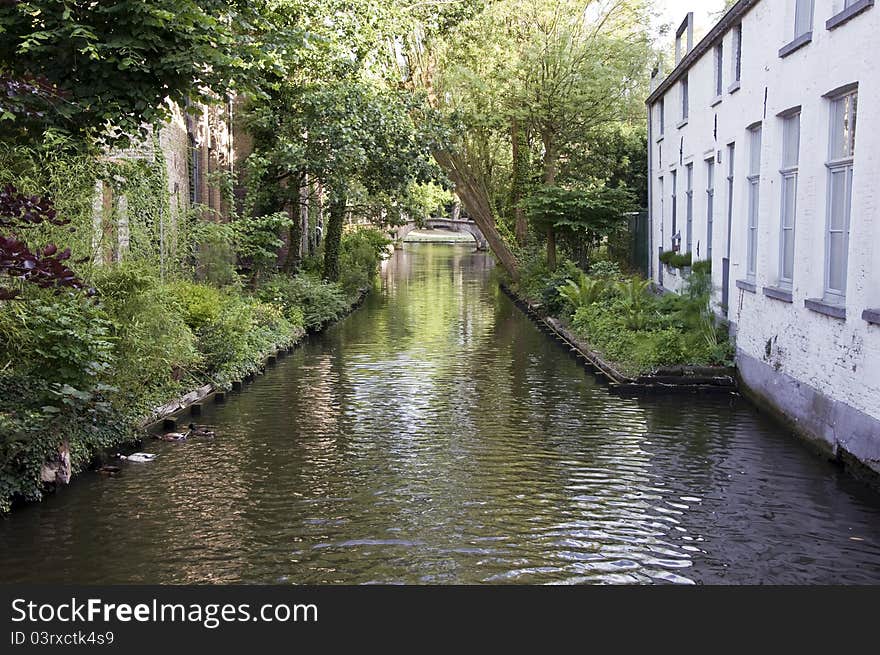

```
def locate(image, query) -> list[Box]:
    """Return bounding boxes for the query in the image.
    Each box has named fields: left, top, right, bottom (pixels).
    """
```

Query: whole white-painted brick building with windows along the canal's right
left=648, top=0, right=880, bottom=472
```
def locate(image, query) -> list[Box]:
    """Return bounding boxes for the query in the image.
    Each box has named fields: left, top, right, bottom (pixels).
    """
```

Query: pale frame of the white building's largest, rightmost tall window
left=823, top=86, right=858, bottom=305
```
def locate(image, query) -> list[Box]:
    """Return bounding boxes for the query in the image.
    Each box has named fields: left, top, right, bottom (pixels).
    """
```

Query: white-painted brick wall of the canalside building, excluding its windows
left=650, top=0, right=880, bottom=428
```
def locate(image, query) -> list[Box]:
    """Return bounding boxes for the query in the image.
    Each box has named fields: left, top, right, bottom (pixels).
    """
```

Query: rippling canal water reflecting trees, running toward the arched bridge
left=0, top=244, right=880, bottom=584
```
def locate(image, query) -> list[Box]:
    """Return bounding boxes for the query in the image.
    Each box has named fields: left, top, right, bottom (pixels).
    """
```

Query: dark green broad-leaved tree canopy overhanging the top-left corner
left=0, top=0, right=279, bottom=142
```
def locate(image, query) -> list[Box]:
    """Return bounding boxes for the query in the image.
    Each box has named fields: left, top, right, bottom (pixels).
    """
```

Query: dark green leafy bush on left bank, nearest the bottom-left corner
left=0, top=289, right=124, bottom=514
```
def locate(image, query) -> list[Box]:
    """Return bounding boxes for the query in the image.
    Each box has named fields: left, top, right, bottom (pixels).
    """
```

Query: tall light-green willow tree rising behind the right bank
left=410, top=0, right=650, bottom=267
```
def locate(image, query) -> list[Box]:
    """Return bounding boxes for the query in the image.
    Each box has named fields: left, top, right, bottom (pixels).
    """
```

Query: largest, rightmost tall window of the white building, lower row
left=825, top=91, right=858, bottom=303
